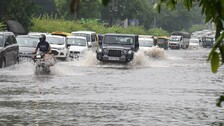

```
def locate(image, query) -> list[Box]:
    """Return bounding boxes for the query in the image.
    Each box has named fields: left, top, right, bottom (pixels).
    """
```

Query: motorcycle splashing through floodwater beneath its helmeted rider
left=34, top=53, right=55, bottom=74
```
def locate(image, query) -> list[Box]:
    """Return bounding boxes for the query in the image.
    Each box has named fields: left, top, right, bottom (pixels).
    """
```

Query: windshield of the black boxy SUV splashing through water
left=104, top=35, right=134, bottom=45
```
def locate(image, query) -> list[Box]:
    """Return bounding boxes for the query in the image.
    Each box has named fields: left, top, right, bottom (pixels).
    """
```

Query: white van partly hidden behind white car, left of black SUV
left=71, top=31, right=97, bottom=48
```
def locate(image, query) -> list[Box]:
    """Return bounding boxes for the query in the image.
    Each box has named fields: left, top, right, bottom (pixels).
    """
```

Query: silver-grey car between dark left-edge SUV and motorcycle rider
left=16, top=35, right=39, bottom=58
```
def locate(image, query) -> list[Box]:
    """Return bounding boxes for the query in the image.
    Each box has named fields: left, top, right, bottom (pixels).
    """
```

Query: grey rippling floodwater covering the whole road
left=0, top=46, right=224, bottom=126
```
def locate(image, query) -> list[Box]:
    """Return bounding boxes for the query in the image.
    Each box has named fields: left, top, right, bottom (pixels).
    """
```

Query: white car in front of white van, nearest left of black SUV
left=67, top=36, right=89, bottom=58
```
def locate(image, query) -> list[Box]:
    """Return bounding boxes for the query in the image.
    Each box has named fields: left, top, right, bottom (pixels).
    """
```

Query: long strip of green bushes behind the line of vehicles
left=30, top=15, right=169, bottom=35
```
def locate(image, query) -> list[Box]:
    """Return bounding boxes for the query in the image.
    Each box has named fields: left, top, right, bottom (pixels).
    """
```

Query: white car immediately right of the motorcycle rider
left=46, top=35, right=69, bottom=60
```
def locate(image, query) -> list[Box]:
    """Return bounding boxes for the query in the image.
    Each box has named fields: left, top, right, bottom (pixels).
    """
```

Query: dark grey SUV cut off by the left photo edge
left=0, top=32, right=19, bottom=68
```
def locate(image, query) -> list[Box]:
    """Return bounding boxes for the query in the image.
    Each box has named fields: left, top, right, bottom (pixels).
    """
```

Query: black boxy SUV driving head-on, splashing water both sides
left=96, top=34, right=139, bottom=63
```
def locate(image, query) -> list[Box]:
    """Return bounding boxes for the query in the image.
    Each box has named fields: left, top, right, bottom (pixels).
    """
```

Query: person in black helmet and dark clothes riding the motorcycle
left=35, top=34, right=51, bottom=54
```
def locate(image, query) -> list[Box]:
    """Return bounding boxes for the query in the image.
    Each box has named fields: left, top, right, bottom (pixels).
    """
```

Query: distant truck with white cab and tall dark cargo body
left=171, top=31, right=191, bottom=49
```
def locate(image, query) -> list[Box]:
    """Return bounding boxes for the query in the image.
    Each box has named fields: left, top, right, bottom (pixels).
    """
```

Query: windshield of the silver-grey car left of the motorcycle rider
left=16, top=37, right=39, bottom=47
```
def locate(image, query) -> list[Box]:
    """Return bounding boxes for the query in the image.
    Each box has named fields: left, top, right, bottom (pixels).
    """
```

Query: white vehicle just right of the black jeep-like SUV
left=138, top=36, right=155, bottom=50
